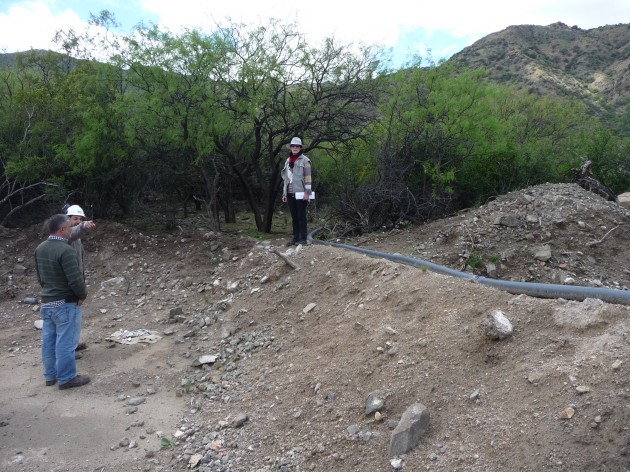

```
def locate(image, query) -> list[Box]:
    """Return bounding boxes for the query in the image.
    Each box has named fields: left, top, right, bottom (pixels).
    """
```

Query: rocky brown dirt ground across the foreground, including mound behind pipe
left=0, top=185, right=630, bottom=472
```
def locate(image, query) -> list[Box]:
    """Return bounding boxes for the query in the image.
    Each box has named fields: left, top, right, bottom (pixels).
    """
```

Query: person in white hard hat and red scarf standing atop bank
left=281, top=137, right=312, bottom=246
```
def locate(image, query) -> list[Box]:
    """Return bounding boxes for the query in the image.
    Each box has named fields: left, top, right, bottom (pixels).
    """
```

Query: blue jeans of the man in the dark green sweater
left=40, top=303, right=81, bottom=384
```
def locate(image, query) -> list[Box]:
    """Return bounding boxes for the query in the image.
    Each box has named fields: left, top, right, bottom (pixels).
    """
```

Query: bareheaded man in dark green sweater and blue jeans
left=35, top=214, right=90, bottom=390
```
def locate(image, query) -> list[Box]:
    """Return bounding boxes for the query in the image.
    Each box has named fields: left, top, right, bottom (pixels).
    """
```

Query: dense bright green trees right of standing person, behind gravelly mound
left=335, top=64, right=608, bottom=229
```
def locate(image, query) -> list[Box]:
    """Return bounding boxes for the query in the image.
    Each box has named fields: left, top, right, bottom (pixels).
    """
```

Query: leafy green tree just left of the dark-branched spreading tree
left=118, top=26, right=223, bottom=229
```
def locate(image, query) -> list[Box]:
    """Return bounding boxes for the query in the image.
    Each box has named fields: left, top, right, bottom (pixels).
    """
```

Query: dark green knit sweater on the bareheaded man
left=35, top=239, right=87, bottom=303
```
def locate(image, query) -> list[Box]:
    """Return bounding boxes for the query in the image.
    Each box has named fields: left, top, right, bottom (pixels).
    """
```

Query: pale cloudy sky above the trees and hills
left=0, top=0, right=630, bottom=66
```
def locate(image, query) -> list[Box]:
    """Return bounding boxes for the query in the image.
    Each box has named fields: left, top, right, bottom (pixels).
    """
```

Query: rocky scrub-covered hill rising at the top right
left=450, top=23, right=630, bottom=135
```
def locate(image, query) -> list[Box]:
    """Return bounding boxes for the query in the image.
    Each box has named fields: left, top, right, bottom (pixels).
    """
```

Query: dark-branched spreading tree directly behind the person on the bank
left=205, top=21, right=378, bottom=232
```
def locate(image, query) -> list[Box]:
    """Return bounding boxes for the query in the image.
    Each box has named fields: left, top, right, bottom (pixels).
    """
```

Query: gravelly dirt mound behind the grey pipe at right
left=359, top=184, right=630, bottom=289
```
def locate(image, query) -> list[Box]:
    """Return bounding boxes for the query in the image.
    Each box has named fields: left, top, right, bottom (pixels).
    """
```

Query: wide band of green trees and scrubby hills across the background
left=0, top=18, right=630, bottom=235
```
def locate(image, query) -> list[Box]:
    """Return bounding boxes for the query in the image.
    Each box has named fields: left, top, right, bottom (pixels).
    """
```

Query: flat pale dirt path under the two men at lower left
left=0, top=305, right=190, bottom=471
